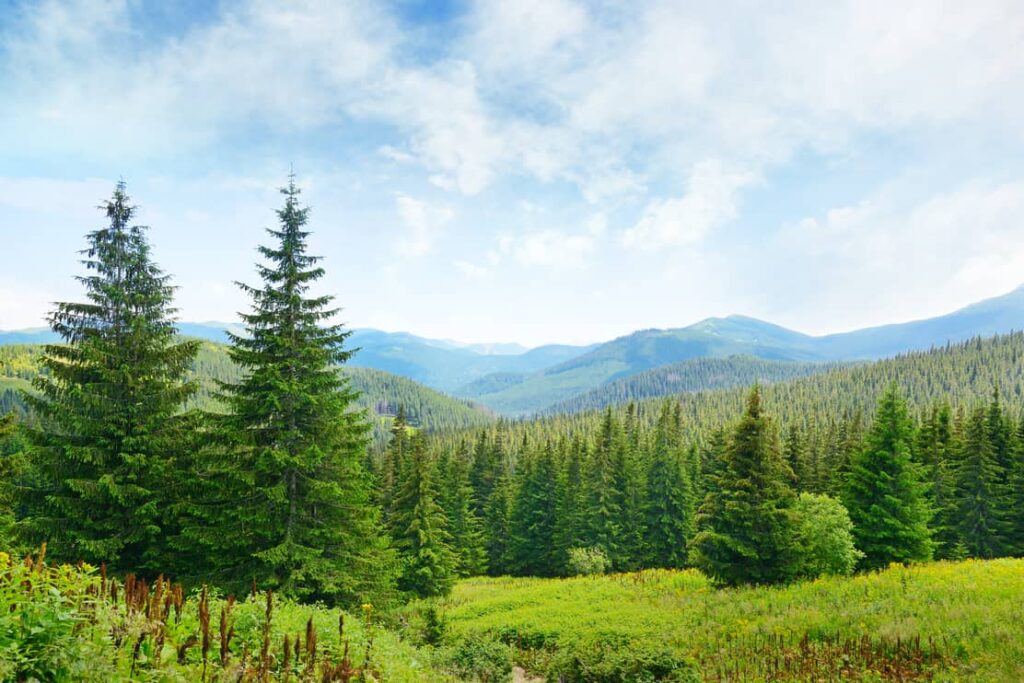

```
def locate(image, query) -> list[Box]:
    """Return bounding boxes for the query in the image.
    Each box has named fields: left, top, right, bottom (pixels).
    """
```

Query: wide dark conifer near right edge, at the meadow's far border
left=956, top=408, right=1011, bottom=559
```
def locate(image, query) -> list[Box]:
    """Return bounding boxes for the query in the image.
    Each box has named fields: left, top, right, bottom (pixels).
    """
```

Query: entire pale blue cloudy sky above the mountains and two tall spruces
left=0, top=0, right=1024, bottom=345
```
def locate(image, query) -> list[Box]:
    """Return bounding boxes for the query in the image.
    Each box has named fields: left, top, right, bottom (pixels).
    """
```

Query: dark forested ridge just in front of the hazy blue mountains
left=544, top=355, right=846, bottom=415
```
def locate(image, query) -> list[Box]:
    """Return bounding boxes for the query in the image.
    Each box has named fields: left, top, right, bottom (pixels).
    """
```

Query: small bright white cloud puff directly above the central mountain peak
left=623, top=160, right=756, bottom=250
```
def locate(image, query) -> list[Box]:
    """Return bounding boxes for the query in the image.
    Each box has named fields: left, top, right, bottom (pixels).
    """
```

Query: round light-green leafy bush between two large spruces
left=794, top=494, right=863, bottom=579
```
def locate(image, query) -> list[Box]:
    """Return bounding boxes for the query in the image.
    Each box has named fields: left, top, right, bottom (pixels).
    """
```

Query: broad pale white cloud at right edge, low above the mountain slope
left=774, top=181, right=1024, bottom=332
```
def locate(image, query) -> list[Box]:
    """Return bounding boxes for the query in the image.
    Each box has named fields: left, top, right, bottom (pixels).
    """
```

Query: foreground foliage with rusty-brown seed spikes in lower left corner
left=0, top=552, right=456, bottom=683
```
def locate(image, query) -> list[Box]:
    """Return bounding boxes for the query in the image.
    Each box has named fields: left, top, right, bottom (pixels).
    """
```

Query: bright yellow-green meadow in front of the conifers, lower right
left=439, top=559, right=1024, bottom=681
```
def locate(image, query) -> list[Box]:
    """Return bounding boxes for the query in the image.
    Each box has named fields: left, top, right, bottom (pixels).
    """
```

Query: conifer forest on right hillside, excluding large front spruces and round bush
left=393, top=333, right=1024, bottom=575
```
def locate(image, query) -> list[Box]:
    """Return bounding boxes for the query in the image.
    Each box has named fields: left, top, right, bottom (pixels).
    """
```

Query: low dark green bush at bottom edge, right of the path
left=549, top=641, right=701, bottom=683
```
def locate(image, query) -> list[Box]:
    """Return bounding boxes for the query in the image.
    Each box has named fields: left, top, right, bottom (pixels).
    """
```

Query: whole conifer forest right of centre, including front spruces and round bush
left=376, top=334, right=1024, bottom=582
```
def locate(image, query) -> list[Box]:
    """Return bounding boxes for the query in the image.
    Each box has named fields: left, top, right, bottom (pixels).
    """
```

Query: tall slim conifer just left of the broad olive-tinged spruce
left=644, top=402, right=694, bottom=568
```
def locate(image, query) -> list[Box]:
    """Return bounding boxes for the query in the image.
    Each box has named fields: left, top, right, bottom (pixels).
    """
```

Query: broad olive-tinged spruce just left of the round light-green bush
left=690, top=387, right=798, bottom=585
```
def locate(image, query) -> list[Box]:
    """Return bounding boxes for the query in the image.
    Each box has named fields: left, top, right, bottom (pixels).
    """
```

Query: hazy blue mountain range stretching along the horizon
left=6, top=287, right=1024, bottom=416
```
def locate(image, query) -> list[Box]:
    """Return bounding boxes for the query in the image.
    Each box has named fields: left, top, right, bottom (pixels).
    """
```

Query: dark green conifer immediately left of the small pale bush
left=509, top=443, right=559, bottom=577
